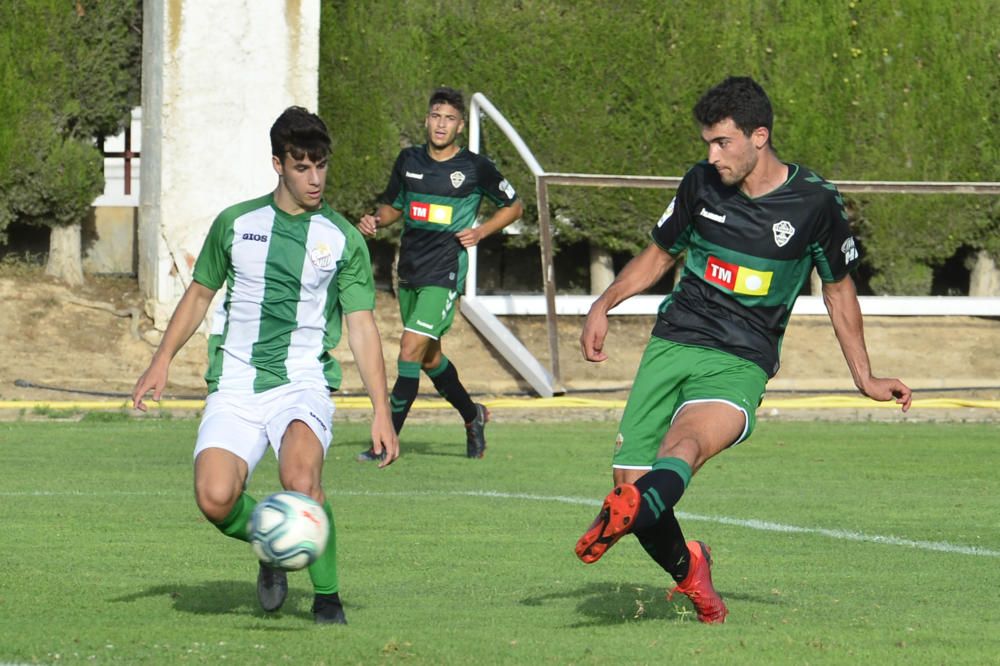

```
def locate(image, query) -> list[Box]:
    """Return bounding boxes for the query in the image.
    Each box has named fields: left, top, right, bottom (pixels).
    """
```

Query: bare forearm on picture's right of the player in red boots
left=823, top=275, right=912, bottom=412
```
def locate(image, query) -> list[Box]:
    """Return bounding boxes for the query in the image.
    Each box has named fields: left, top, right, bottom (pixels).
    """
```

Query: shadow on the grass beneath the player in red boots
left=521, top=582, right=780, bottom=629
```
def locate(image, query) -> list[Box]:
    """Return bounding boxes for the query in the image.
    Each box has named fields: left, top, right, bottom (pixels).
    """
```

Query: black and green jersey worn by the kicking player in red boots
left=652, top=162, right=860, bottom=377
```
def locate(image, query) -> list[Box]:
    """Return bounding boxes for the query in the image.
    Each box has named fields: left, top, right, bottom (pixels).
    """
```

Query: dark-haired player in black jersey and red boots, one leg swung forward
left=576, top=77, right=911, bottom=623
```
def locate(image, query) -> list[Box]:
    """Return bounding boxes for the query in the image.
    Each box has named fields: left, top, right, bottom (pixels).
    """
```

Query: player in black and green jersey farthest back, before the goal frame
left=358, top=87, right=524, bottom=461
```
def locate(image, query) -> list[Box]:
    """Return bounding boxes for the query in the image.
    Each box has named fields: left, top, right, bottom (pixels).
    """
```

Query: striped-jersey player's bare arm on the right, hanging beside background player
left=344, top=310, right=399, bottom=467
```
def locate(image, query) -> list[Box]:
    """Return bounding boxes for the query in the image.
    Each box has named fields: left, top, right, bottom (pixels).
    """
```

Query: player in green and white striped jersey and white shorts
left=132, top=106, right=399, bottom=624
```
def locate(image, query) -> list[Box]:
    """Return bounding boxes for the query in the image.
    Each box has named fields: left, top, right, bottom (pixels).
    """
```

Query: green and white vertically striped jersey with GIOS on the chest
left=193, top=194, right=375, bottom=393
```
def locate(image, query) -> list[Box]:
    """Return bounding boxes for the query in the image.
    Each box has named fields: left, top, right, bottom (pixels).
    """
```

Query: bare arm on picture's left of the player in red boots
left=580, top=243, right=676, bottom=362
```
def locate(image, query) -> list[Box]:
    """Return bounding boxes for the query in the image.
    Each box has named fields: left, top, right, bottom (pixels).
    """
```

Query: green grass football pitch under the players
left=0, top=413, right=1000, bottom=664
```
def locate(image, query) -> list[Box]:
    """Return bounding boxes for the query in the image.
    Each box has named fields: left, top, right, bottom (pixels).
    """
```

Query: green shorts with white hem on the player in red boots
left=612, top=336, right=767, bottom=469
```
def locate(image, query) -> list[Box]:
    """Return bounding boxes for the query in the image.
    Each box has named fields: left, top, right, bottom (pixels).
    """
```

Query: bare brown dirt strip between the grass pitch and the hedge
left=0, top=270, right=1000, bottom=418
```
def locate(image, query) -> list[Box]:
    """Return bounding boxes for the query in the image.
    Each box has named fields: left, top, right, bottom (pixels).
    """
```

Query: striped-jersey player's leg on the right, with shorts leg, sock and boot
left=268, top=389, right=347, bottom=624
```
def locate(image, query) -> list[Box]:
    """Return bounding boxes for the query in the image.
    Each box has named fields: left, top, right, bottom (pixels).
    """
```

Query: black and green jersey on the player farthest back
left=379, top=145, right=517, bottom=291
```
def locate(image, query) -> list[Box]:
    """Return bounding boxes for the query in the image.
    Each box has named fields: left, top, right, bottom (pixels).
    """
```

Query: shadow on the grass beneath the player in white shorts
left=111, top=580, right=313, bottom=631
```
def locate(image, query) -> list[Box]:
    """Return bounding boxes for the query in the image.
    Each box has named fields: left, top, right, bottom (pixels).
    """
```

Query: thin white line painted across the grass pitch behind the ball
left=0, top=490, right=1000, bottom=557
